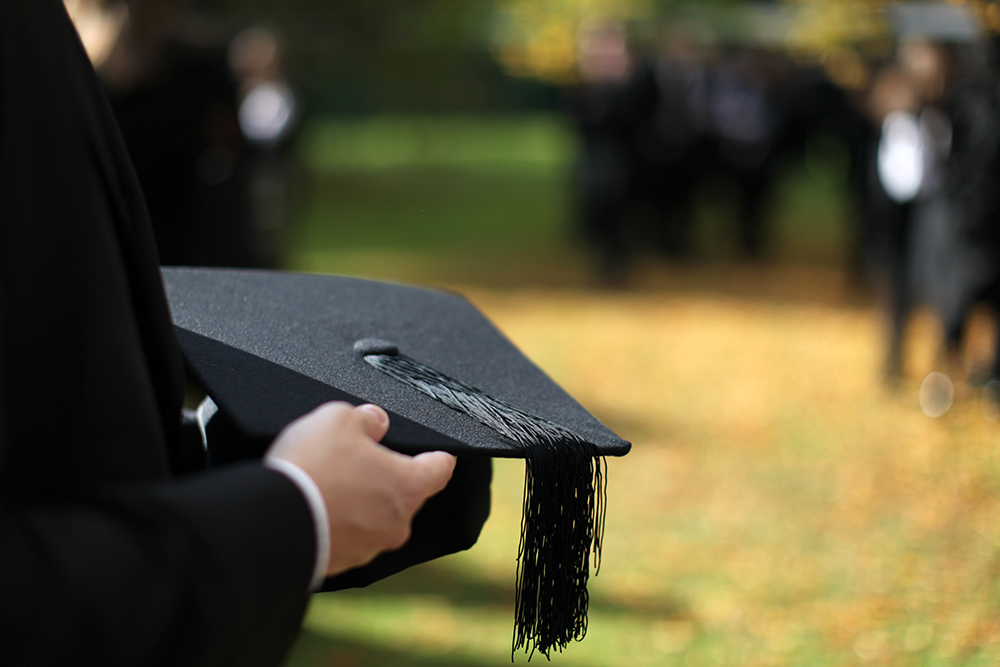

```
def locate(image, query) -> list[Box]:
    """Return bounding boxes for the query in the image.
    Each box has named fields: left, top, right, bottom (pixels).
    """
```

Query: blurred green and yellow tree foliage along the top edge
left=184, top=0, right=980, bottom=113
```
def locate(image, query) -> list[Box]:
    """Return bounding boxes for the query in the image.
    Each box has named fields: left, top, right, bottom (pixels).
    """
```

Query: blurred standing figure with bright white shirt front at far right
left=871, top=27, right=1000, bottom=392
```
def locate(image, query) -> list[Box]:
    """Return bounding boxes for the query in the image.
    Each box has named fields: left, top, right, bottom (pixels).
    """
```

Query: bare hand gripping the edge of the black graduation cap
left=266, top=403, right=455, bottom=575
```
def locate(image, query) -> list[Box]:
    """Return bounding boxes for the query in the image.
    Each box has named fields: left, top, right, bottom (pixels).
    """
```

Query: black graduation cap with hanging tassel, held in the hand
left=163, top=268, right=631, bottom=656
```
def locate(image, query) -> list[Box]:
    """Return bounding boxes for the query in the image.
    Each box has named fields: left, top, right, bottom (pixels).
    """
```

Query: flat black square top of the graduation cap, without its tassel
left=163, top=268, right=630, bottom=457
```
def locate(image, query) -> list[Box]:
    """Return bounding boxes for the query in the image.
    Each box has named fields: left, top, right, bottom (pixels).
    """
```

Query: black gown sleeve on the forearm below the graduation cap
left=0, top=464, right=315, bottom=667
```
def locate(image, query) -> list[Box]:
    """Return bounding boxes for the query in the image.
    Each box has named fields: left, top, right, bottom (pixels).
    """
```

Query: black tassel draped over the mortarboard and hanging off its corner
left=363, top=352, right=607, bottom=660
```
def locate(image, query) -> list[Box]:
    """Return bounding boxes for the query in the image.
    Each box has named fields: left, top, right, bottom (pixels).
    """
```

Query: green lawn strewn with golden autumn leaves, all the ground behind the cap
left=278, top=119, right=1000, bottom=667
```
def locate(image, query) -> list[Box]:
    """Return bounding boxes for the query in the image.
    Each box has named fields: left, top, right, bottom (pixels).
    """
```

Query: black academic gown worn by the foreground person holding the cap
left=0, top=0, right=315, bottom=667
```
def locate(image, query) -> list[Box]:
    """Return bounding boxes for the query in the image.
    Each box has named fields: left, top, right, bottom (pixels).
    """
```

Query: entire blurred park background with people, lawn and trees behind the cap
left=66, top=0, right=1000, bottom=667
